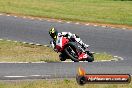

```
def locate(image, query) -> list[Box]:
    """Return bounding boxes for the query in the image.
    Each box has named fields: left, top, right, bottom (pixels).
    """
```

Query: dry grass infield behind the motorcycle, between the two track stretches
left=0, top=40, right=113, bottom=62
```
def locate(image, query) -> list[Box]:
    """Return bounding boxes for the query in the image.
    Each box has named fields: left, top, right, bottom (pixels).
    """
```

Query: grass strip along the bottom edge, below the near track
left=0, top=79, right=132, bottom=88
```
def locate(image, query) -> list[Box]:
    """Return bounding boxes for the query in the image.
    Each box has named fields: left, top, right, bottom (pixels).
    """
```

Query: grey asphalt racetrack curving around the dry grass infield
left=0, top=15, right=132, bottom=80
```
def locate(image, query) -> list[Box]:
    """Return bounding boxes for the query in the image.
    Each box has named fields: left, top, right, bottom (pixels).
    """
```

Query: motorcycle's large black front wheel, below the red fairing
left=65, top=42, right=79, bottom=62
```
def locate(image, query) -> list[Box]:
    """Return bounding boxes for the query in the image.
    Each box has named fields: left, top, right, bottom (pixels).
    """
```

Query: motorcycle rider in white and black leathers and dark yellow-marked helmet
left=49, top=28, right=89, bottom=50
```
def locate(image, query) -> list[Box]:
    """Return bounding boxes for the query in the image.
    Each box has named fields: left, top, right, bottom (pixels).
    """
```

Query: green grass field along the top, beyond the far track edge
left=0, top=0, right=132, bottom=26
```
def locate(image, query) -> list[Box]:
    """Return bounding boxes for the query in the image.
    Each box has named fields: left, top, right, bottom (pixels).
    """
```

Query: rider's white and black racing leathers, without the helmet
left=50, top=32, right=89, bottom=50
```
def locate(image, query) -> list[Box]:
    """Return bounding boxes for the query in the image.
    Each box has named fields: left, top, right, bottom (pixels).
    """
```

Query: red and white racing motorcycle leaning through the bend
left=52, top=36, right=94, bottom=62
